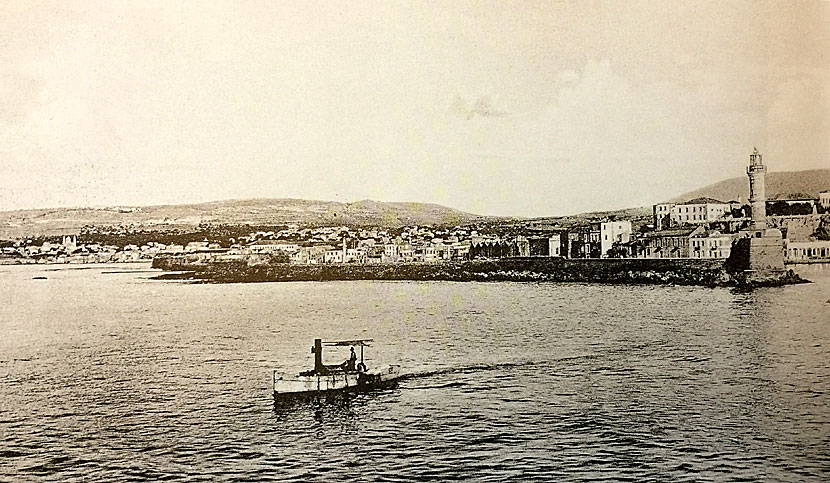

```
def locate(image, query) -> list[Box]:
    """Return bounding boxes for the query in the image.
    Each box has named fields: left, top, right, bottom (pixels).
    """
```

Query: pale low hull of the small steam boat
left=274, top=365, right=400, bottom=397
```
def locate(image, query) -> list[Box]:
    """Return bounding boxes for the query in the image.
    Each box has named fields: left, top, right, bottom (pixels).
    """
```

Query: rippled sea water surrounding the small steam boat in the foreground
left=0, top=265, right=830, bottom=481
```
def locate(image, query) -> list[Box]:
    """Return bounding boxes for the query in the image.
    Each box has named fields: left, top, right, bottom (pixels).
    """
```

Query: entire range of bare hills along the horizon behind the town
left=0, top=169, right=830, bottom=239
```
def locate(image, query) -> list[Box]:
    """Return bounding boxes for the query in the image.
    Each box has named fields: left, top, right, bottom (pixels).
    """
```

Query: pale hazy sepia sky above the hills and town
left=0, top=0, right=830, bottom=216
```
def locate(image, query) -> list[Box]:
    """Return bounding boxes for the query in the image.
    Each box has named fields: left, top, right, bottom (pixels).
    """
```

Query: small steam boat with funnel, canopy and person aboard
left=274, top=339, right=400, bottom=398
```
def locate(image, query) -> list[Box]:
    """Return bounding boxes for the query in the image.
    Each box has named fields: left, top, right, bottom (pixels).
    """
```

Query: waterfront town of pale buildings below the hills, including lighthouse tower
left=0, top=150, right=830, bottom=265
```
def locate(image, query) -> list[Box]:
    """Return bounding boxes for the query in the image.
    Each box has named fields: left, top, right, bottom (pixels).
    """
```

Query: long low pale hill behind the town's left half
left=0, top=198, right=492, bottom=239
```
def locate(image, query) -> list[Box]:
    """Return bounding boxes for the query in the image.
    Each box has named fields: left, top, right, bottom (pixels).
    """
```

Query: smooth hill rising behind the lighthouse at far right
left=671, top=169, right=830, bottom=203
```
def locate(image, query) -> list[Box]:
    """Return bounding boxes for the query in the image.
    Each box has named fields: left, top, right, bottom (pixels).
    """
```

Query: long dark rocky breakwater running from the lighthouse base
left=153, top=255, right=803, bottom=287
